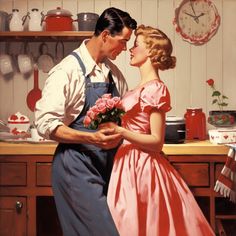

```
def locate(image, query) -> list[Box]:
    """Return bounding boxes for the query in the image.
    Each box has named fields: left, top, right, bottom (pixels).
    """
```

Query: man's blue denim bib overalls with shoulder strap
left=52, top=52, right=119, bottom=236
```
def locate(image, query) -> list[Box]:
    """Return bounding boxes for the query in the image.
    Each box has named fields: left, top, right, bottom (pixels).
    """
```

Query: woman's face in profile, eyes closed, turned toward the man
left=129, top=35, right=149, bottom=67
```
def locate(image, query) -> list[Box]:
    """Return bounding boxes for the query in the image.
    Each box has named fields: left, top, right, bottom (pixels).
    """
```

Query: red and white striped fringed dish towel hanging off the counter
left=214, top=144, right=236, bottom=203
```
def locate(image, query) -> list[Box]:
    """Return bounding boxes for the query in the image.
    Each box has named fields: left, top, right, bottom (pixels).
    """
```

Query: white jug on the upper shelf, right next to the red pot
left=29, top=8, right=43, bottom=31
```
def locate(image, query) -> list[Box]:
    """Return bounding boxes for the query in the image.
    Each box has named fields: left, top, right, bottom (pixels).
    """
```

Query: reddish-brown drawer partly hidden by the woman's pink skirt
left=172, top=163, right=209, bottom=187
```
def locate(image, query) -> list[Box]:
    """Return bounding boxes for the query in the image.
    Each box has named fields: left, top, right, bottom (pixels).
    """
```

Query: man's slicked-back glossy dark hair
left=94, top=7, right=137, bottom=36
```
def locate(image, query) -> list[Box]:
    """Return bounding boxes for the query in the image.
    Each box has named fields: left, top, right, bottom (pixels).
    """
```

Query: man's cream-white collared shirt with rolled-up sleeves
left=35, top=40, right=128, bottom=139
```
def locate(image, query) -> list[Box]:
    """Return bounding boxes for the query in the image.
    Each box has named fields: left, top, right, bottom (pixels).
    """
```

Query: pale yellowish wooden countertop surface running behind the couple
left=0, top=140, right=229, bottom=155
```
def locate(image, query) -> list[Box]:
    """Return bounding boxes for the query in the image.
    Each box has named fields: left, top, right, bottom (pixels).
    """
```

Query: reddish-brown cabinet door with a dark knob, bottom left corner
left=0, top=197, right=27, bottom=236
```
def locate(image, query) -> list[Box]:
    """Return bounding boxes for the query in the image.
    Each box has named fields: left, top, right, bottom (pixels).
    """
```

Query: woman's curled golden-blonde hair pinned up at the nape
left=135, top=25, right=176, bottom=70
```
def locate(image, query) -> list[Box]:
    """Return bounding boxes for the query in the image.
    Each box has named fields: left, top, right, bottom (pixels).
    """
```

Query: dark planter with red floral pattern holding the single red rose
left=207, top=110, right=236, bottom=127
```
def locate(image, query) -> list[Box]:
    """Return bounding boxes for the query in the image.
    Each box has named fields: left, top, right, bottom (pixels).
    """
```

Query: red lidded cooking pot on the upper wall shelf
left=44, top=7, right=74, bottom=31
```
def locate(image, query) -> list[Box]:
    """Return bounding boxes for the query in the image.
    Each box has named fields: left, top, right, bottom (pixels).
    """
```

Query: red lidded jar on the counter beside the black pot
left=184, top=108, right=206, bottom=140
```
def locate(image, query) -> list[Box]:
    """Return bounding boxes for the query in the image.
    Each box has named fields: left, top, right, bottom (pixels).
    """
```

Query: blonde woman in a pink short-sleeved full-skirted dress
left=108, top=25, right=214, bottom=236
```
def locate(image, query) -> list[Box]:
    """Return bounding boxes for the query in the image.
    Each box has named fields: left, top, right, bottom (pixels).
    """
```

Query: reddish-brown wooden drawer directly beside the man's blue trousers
left=36, top=162, right=52, bottom=186
